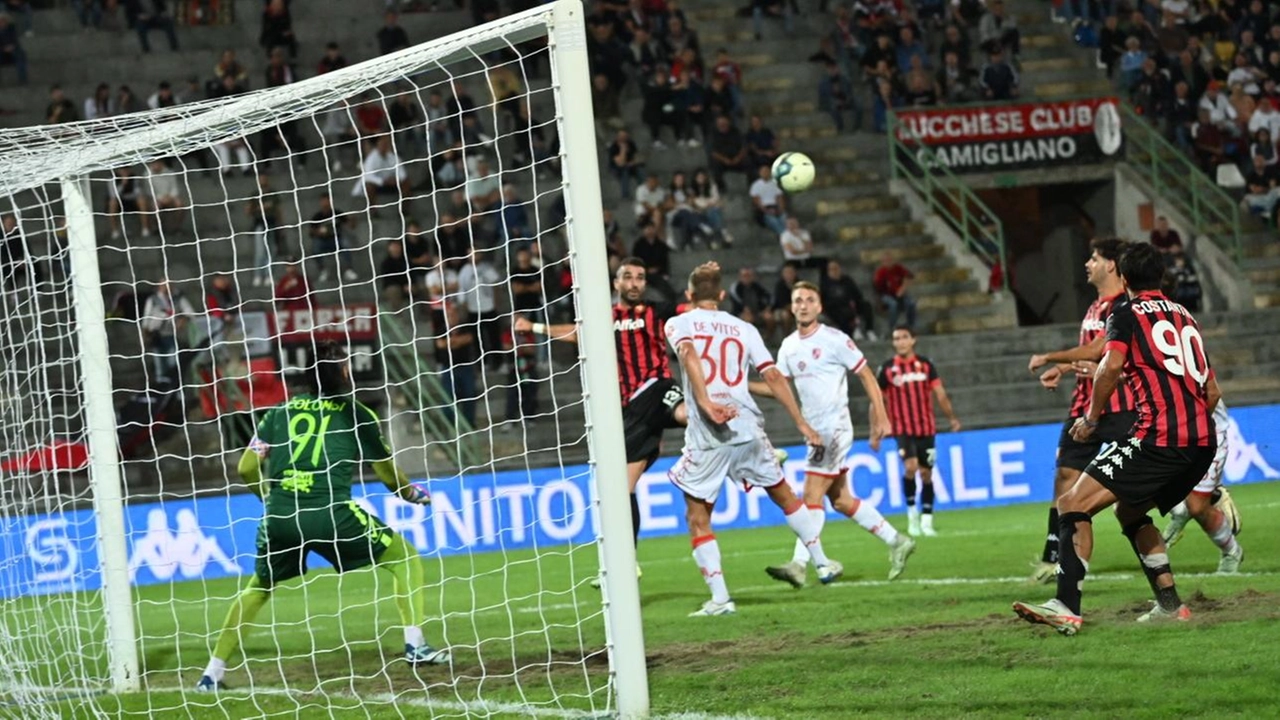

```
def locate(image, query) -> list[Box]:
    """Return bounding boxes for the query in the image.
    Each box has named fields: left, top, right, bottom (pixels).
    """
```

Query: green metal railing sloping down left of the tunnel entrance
left=886, top=111, right=1009, bottom=286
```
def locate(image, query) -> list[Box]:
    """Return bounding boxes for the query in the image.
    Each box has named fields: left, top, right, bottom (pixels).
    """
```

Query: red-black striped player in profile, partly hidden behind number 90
left=1028, top=237, right=1138, bottom=583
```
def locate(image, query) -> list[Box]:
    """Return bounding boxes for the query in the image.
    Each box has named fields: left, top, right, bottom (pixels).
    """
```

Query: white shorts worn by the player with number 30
left=667, top=436, right=782, bottom=502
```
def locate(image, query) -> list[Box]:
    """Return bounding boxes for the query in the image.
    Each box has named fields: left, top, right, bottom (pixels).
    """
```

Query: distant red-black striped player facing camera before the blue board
left=877, top=325, right=960, bottom=536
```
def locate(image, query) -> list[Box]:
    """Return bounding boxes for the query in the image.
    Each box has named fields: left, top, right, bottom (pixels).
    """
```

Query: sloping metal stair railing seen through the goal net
left=378, top=306, right=481, bottom=470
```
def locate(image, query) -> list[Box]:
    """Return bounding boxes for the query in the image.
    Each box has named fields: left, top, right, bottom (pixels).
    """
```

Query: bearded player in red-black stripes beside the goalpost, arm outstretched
left=516, top=258, right=689, bottom=550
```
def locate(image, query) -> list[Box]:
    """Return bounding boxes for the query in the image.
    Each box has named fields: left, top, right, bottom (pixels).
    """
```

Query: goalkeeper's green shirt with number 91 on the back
left=250, top=395, right=392, bottom=515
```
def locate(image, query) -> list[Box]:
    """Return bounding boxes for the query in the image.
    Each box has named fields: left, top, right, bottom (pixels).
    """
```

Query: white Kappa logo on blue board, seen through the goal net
left=129, top=507, right=241, bottom=582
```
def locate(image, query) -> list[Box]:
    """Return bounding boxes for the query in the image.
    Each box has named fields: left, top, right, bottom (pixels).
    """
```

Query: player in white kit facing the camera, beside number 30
left=751, top=281, right=915, bottom=588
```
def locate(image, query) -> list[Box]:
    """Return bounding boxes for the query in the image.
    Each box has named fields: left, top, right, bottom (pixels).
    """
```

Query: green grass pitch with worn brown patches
left=27, top=483, right=1280, bottom=719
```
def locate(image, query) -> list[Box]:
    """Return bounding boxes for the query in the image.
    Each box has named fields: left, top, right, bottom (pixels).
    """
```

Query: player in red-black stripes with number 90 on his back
left=1014, top=243, right=1221, bottom=635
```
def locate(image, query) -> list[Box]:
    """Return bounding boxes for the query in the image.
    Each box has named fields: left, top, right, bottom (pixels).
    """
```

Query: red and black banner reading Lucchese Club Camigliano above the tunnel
left=895, top=97, right=1121, bottom=173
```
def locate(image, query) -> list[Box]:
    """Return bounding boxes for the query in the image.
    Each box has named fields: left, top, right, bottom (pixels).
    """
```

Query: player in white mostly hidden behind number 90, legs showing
left=1164, top=400, right=1244, bottom=575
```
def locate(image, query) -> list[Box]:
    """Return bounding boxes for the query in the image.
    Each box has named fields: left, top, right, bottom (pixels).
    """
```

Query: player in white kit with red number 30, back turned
left=667, top=263, right=844, bottom=618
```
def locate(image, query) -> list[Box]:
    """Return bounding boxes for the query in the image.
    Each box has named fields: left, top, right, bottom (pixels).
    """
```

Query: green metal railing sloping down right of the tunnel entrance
left=1120, top=102, right=1244, bottom=265
